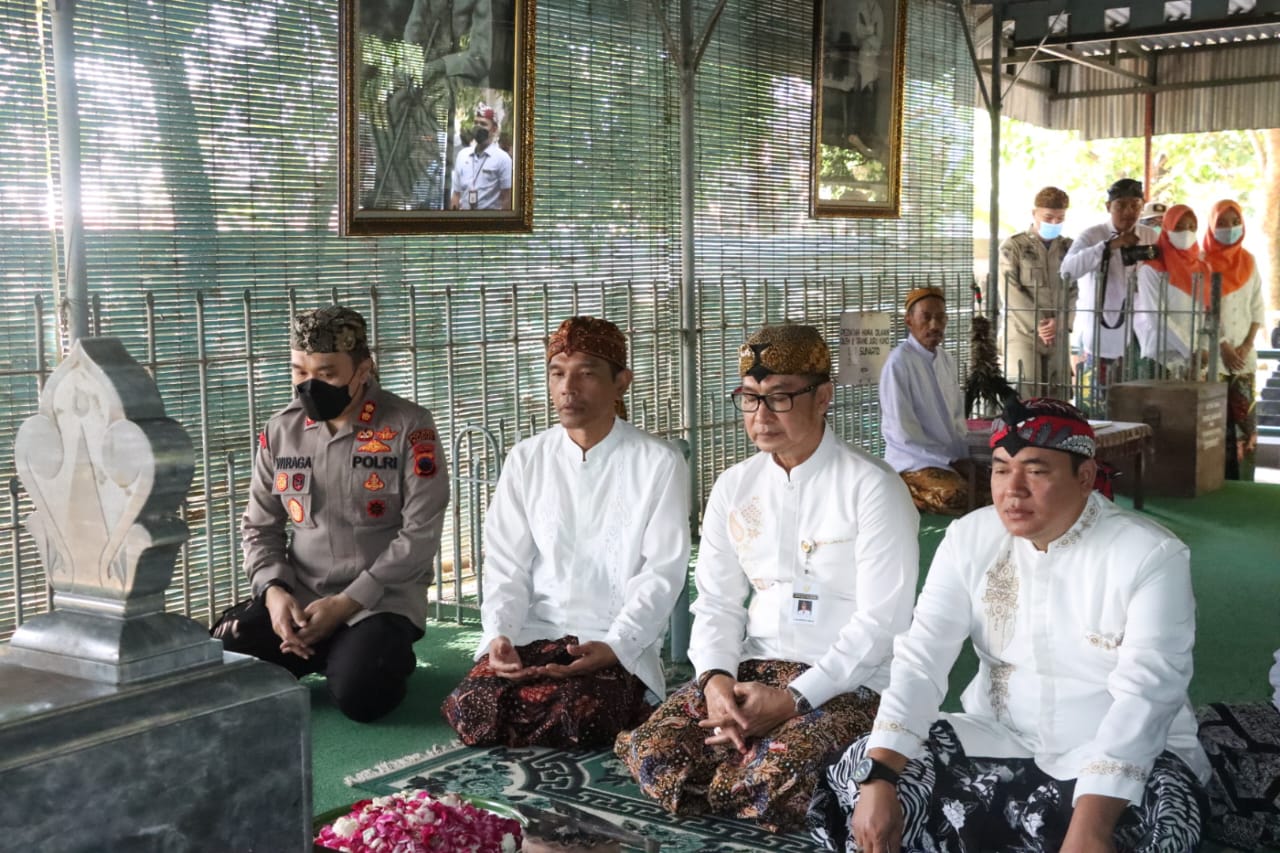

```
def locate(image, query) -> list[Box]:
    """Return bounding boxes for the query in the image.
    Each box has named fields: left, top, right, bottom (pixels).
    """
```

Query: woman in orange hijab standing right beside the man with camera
left=1133, top=205, right=1210, bottom=371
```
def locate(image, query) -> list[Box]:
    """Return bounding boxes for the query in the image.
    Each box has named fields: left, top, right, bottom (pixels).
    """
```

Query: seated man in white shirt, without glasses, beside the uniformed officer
left=443, top=316, right=689, bottom=748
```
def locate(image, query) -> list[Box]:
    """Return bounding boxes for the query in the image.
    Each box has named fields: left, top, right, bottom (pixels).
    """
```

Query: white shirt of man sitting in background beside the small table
left=879, top=334, right=969, bottom=471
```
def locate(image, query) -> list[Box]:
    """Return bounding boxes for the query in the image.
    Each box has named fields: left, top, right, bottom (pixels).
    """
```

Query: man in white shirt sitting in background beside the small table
left=879, top=287, right=969, bottom=515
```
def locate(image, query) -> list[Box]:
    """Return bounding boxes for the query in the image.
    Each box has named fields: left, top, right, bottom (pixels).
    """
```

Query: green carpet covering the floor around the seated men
left=311, top=483, right=1280, bottom=840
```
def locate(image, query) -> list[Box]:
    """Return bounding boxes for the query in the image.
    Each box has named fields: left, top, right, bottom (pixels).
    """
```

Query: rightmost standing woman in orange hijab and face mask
left=1204, top=200, right=1267, bottom=480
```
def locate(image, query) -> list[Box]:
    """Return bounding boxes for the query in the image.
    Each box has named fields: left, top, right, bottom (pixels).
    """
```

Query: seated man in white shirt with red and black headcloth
left=810, top=398, right=1208, bottom=853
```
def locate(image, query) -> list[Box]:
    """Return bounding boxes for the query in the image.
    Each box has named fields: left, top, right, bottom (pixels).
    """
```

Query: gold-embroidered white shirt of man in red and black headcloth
left=868, top=493, right=1210, bottom=802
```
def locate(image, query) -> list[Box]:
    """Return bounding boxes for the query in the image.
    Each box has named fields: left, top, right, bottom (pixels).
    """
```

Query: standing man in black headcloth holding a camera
left=1061, top=178, right=1157, bottom=394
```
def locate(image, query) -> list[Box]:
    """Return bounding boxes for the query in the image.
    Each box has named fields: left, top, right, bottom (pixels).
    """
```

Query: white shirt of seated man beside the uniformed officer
left=476, top=419, right=689, bottom=697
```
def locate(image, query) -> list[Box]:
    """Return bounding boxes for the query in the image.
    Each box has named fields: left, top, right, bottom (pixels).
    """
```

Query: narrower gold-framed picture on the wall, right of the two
left=809, top=0, right=908, bottom=216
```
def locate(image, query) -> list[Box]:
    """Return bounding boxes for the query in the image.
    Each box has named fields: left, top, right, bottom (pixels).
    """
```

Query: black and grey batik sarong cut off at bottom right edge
left=1196, top=702, right=1280, bottom=850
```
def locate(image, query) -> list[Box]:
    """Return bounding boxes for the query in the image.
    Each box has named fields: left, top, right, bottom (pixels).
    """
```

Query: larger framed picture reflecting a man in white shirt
left=338, top=0, right=535, bottom=236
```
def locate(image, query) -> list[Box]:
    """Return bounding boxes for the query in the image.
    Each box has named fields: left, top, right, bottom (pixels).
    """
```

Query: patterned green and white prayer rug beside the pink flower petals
left=346, top=744, right=817, bottom=853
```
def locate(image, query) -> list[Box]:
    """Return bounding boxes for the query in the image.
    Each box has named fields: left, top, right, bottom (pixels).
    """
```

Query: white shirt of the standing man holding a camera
left=1060, top=220, right=1157, bottom=359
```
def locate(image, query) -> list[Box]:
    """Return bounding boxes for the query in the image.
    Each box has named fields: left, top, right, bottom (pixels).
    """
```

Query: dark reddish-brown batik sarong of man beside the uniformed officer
left=440, top=635, right=653, bottom=749
